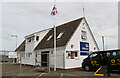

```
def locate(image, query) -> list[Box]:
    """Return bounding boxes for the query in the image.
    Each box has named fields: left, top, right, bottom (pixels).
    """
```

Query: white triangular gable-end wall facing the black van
left=65, top=20, right=98, bottom=69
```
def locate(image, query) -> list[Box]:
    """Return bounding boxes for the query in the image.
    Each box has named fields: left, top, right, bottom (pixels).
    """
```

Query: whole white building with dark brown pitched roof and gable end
left=16, top=17, right=99, bottom=69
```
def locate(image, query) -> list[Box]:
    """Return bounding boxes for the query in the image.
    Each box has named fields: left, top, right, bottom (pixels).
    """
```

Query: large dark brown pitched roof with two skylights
left=34, top=18, right=83, bottom=50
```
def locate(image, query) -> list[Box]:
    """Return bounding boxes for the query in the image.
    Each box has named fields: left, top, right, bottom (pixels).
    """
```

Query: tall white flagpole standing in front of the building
left=54, top=0, right=56, bottom=71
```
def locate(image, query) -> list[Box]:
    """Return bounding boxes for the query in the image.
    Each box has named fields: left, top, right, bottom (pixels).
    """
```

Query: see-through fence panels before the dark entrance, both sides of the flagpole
left=35, top=53, right=65, bottom=72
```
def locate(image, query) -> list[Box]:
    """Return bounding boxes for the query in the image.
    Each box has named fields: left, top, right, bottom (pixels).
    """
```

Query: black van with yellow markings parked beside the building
left=82, top=49, right=120, bottom=71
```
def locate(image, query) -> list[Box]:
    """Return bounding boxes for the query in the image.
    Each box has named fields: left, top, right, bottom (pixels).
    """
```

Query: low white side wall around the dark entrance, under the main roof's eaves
left=36, top=47, right=65, bottom=69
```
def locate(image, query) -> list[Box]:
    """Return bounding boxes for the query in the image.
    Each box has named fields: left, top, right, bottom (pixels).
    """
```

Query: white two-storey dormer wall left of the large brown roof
left=22, top=29, right=50, bottom=65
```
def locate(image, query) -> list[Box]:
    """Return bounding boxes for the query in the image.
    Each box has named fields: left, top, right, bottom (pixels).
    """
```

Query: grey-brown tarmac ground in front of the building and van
left=2, top=63, right=120, bottom=78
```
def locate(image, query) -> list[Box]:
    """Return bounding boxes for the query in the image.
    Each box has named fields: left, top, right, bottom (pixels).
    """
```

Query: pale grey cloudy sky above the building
left=2, top=2, right=118, bottom=50
